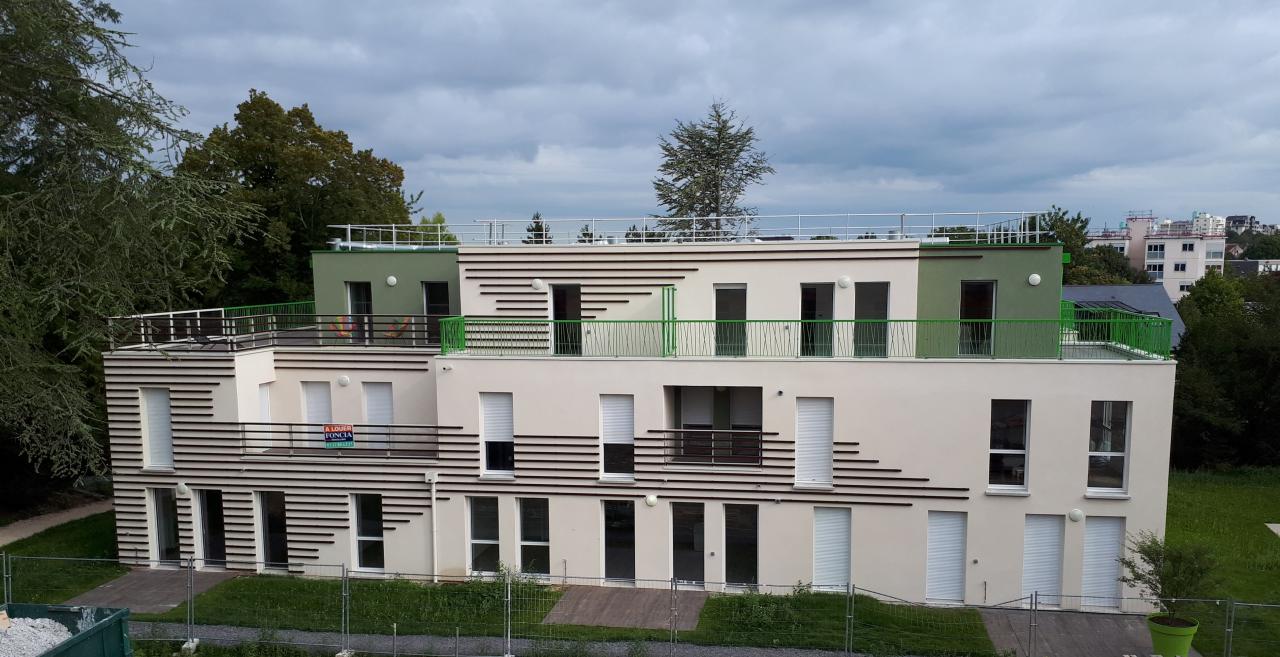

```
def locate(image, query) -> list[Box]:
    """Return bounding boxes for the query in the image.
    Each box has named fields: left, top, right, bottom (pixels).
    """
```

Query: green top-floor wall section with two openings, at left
left=311, top=251, right=461, bottom=315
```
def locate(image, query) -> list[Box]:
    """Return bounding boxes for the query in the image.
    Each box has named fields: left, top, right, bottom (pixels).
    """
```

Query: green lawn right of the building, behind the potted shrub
left=1166, top=467, right=1280, bottom=656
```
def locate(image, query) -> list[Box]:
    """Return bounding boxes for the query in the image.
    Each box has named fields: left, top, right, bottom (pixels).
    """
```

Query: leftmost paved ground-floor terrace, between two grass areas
left=67, top=567, right=237, bottom=613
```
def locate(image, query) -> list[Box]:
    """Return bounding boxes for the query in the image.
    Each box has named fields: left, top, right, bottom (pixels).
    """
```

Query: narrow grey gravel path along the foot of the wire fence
left=129, top=622, right=860, bottom=657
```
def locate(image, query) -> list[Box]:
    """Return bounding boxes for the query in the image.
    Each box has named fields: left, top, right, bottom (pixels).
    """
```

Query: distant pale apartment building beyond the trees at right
left=1088, top=213, right=1226, bottom=301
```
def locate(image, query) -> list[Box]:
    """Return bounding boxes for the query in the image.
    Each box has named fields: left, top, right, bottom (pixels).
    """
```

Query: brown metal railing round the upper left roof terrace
left=110, top=312, right=447, bottom=351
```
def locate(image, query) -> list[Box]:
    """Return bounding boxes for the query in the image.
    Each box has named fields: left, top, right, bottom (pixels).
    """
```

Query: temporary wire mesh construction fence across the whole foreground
left=0, top=555, right=1280, bottom=657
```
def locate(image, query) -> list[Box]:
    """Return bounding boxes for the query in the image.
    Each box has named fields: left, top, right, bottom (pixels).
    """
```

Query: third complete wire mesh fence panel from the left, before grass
left=348, top=571, right=507, bottom=654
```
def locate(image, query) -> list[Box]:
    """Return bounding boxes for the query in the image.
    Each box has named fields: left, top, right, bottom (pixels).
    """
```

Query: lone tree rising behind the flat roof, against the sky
left=653, top=101, right=774, bottom=232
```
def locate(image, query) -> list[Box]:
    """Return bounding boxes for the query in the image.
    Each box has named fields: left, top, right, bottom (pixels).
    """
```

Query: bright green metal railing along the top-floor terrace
left=440, top=309, right=1171, bottom=360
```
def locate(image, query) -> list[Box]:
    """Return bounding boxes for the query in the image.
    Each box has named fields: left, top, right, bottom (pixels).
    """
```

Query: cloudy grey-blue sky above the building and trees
left=115, top=0, right=1280, bottom=225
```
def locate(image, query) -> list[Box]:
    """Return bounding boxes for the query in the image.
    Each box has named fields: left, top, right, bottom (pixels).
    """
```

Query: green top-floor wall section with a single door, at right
left=916, top=245, right=1062, bottom=359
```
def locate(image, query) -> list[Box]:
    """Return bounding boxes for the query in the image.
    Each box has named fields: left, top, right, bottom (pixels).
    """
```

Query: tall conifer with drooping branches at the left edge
left=0, top=0, right=256, bottom=473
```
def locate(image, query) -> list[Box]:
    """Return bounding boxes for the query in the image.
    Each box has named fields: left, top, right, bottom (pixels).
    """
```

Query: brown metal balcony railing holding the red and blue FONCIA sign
left=239, top=423, right=445, bottom=460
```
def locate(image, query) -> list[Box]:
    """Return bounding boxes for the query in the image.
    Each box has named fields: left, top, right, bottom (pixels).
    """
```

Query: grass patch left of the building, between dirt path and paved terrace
left=4, top=512, right=128, bottom=604
